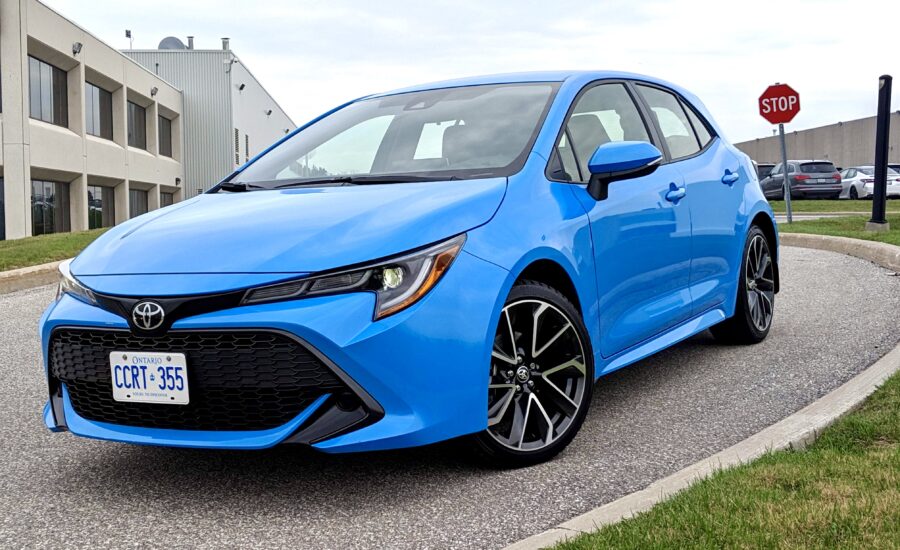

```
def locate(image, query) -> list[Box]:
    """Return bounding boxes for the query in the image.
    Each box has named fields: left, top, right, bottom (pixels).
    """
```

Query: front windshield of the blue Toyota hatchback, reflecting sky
left=232, top=82, right=558, bottom=188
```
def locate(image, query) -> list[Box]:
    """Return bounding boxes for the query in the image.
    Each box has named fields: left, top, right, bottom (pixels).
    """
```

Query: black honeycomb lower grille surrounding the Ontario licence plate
left=50, top=329, right=349, bottom=430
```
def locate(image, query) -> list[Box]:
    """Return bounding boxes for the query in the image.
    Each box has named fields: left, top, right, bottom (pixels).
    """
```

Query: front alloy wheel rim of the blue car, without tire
left=487, top=299, right=588, bottom=451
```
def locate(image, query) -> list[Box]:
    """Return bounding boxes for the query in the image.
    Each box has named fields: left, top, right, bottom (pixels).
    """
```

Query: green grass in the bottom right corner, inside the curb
left=556, top=375, right=900, bottom=550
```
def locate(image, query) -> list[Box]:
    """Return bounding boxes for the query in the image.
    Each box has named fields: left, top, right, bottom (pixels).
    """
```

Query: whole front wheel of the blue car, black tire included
left=470, top=281, right=594, bottom=468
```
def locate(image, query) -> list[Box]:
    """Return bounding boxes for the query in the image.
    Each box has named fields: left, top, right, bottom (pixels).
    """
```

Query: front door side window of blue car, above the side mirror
left=553, top=83, right=650, bottom=183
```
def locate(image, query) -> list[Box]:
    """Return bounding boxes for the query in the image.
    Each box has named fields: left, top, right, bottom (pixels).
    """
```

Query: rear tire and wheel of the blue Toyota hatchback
left=710, top=225, right=775, bottom=344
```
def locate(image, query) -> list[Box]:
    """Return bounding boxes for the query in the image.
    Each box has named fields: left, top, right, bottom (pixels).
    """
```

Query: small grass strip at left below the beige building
left=0, top=229, right=106, bottom=271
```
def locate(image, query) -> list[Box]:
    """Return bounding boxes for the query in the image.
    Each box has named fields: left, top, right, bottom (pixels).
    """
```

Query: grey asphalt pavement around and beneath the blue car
left=0, top=248, right=900, bottom=548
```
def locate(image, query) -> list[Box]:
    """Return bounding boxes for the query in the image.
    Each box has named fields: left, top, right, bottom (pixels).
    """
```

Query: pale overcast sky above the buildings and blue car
left=43, top=0, right=900, bottom=141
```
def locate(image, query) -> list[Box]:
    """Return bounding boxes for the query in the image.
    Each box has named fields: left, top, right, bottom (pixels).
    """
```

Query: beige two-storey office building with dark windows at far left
left=0, top=0, right=184, bottom=239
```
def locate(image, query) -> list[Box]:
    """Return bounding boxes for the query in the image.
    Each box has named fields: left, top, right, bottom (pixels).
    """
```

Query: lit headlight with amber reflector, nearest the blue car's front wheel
left=241, top=235, right=466, bottom=320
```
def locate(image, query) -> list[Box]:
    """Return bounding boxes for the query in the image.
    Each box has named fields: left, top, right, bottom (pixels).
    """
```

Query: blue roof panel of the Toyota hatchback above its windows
left=367, top=71, right=693, bottom=98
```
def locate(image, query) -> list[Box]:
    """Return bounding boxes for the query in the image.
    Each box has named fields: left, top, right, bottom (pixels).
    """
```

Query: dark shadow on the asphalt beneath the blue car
left=47, top=335, right=724, bottom=514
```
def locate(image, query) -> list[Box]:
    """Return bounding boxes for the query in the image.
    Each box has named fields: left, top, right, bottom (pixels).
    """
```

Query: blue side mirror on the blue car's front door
left=588, top=141, right=662, bottom=201
